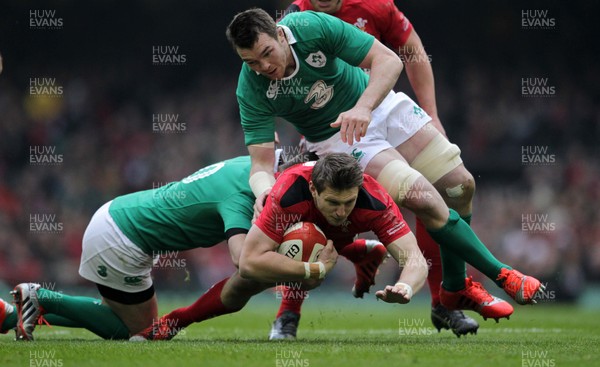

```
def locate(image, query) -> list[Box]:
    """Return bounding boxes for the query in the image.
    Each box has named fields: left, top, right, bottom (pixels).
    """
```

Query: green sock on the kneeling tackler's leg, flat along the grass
left=37, top=288, right=129, bottom=339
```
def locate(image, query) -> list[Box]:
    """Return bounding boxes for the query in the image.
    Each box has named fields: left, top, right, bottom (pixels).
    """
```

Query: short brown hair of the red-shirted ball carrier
left=311, top=153, right=364, bottom=193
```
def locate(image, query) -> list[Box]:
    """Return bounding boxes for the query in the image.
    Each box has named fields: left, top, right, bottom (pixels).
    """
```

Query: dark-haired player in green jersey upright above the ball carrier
left=226, top=8, right=544, bottom=326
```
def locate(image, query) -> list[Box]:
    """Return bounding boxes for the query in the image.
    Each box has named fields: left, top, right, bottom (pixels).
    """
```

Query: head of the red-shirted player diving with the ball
left=309, top=153, right=364, bottom=226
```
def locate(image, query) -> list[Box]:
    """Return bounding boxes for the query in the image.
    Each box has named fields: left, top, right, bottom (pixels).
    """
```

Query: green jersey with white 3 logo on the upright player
left=236, top=11, right=374, bottom=145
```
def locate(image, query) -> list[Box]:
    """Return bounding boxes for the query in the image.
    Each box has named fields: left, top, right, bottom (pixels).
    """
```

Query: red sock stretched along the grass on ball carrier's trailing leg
left=164, top=278, right=239, bottom=327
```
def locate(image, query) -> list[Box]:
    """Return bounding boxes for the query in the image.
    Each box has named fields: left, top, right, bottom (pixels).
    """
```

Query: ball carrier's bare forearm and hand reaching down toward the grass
left=375, top=232, right=428, bottom=304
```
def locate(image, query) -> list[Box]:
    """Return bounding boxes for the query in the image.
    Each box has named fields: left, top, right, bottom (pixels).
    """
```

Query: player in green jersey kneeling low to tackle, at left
left=0, top=156, right=292, bottom=340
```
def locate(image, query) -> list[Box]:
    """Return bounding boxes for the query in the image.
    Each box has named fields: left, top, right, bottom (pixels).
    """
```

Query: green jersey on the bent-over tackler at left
left=109, top=156, right=255, bottom=255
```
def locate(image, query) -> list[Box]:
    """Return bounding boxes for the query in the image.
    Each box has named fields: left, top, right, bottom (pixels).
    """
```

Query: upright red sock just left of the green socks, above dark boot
left=417, top=218, right=442, bottom=307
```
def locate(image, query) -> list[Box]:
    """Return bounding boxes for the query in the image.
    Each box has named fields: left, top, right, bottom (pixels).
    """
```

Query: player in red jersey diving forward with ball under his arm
left=133, top=153, right=432, bottom=340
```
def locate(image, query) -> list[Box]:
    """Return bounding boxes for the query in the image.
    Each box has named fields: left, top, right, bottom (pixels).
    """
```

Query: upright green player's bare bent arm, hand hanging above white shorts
left=331, top=40, right=402, bottom=145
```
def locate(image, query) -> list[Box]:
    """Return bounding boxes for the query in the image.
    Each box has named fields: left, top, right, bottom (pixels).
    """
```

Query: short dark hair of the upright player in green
left=225, top=8, right=277, bottom=49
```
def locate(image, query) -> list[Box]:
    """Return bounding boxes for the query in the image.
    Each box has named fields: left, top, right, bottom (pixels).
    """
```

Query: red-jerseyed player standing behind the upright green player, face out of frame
left=271, top=0, right=479, bottom=339
